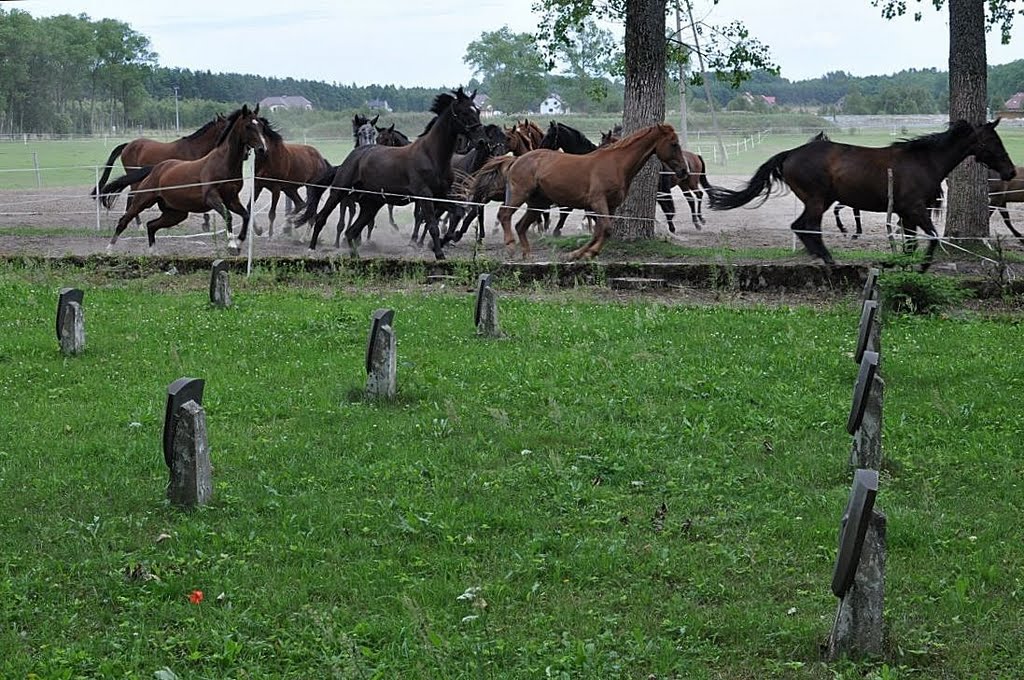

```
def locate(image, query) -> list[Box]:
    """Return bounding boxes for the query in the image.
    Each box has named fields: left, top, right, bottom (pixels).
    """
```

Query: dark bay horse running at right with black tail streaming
left=708, top=119, right=1016, bottom=271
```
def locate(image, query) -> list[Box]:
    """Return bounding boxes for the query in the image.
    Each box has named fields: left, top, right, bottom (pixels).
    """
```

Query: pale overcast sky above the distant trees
left=8, top=0, right=1024, bottom=87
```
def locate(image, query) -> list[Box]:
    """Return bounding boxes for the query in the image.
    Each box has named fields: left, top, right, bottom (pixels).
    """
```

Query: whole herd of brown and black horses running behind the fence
left=93, top=87, right=1024, bottom=267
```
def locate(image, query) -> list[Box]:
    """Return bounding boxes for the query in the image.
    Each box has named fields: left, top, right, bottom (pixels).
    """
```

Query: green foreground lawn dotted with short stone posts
left=0, top=265, right=1024, bottom=679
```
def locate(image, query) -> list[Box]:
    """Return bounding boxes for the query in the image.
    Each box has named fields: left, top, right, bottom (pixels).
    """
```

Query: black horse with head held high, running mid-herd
left=292, top=87, right=482, bottom=260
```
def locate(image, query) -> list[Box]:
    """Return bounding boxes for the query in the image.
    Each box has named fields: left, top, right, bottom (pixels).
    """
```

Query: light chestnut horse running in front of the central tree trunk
left=498, top=124, right=686, bottom=260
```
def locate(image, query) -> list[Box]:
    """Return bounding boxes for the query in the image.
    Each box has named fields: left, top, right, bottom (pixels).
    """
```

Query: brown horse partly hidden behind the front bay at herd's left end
left=89, top=114, right=227, bottom=229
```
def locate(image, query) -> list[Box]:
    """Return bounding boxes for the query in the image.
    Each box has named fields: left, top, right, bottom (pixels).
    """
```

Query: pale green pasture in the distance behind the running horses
left=0, top=118, right=1024, bottom=188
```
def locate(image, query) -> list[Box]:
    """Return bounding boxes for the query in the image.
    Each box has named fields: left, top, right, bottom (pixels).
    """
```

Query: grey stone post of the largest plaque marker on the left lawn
left=167, top=399, right=213, bottom=509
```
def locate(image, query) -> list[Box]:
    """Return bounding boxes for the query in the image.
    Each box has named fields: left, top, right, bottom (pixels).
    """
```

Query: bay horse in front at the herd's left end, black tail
left=100, top=104, right=267, bottom=252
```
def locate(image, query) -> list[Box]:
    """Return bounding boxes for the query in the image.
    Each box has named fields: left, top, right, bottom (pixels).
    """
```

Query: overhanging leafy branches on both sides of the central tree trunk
left=534, top=0, right=779, bottom=88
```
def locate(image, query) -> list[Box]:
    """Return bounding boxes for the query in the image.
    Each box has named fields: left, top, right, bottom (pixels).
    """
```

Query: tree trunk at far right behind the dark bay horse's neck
left=946, top=0, right=988, bottom=238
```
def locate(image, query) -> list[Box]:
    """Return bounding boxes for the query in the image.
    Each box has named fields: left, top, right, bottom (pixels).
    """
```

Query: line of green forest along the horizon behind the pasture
left=0, top=9, right=1024, bottom=134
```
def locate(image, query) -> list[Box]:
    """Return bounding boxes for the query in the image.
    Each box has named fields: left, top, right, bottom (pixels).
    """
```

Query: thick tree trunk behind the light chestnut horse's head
left=614, top=0, right=666, bottom=240
